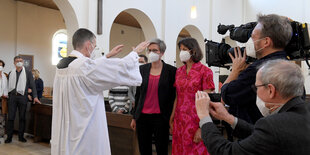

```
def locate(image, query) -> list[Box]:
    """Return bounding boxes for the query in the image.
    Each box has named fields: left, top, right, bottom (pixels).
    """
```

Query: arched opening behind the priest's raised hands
left=109, top=9, right=157, bottom=57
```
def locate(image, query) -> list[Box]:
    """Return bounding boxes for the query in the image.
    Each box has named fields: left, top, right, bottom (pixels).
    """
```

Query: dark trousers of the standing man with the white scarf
left=7, top=95, right=27, bottom=139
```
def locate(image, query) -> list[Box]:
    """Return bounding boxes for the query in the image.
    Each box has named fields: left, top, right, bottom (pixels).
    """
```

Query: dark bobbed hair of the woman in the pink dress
left=178, top=37, right=202, bottom=63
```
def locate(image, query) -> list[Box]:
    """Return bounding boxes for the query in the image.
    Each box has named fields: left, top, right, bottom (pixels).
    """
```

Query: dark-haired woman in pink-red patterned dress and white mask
left=170, top=38, right=214, bottom=155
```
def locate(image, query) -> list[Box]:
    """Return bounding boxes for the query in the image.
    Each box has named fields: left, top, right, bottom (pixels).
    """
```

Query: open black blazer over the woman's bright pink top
left=133, top=61, right=177, bottom=121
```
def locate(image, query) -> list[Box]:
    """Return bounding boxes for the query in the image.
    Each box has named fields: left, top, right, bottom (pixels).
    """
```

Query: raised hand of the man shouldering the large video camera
left=224, top=47, right=248, bottom=84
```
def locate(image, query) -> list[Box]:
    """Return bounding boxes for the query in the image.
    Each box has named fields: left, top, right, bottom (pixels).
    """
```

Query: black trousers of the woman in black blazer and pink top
left=136, top=114, right=169, bottom=155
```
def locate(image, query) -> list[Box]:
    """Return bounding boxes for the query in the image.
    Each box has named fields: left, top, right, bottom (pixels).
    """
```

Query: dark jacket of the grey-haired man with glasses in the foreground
left=201, top=97, right=310, bottom=155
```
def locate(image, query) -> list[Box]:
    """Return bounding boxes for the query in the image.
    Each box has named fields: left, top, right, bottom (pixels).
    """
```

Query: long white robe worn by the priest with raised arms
left=51, top=51, right=142, bottom=155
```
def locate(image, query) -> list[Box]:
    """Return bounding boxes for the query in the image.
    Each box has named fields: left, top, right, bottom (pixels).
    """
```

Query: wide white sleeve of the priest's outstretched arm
left=80, top=52, right=142, bottom=93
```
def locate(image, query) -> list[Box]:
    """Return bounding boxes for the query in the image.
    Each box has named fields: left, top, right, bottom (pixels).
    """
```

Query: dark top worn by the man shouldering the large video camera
left=221, top=51, right=287, bottom=124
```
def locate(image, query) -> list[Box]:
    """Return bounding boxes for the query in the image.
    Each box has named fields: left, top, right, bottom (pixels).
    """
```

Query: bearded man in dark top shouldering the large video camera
left=221, top=14, right=292, bottom=124
